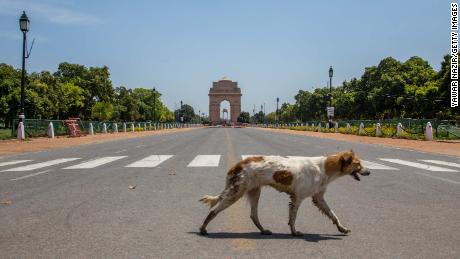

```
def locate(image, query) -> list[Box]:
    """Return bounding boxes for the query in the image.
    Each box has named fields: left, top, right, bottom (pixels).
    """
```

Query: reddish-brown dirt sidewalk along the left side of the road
left=0, top=128, right=197, bottom=156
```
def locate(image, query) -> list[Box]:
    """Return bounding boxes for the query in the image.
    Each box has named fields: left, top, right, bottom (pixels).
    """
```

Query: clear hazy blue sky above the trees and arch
left=0, top=0, right=451, bottom=114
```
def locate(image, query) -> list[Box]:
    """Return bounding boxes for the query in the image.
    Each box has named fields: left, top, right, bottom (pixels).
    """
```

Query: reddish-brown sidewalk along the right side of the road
left=259, top=128, right=460, bottom=157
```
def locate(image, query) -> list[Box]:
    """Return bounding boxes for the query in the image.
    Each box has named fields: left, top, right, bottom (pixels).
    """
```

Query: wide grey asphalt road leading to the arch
left=0, top=128, right=460, bottom=258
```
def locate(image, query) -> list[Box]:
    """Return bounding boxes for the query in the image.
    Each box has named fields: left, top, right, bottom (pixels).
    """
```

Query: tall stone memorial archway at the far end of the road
left=208, top=77, right=242, bottom=125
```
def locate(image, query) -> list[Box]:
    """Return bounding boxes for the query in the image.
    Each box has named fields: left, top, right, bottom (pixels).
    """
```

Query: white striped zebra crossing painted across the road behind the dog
left=0, top=154, right=460, bottom=181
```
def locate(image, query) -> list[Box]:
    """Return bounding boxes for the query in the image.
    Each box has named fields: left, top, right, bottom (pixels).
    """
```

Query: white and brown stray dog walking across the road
left=200, top=150, right=370, bottom=236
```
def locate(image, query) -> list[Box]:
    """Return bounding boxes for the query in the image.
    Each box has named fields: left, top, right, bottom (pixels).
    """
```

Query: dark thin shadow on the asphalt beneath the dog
left=188, top=232, right=346, bottom=243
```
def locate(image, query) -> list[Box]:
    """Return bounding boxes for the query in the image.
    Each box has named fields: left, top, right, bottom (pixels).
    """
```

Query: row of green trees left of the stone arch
left=0, top=63, right=203, bottom=127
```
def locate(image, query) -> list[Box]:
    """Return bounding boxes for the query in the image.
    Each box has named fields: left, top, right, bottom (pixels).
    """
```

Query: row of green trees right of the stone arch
left=240, top=55, right=460, bottom=123
